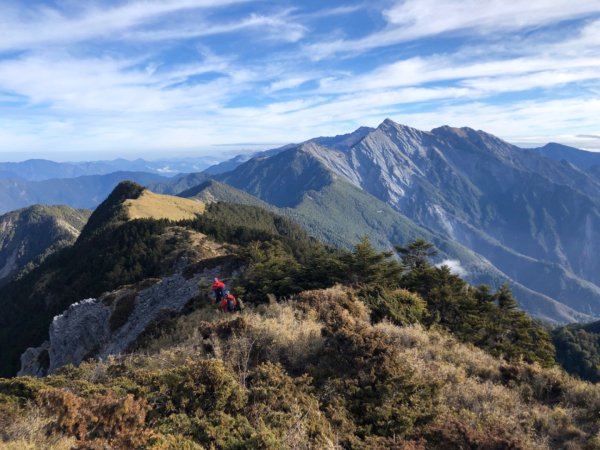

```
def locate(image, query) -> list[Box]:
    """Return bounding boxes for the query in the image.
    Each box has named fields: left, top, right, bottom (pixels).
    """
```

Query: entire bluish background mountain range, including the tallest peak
left=0, top=119, right=600, bottom=322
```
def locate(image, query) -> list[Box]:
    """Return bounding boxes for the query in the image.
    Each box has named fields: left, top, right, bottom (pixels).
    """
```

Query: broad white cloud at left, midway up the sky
left=0, top=47, right=259, bottom=114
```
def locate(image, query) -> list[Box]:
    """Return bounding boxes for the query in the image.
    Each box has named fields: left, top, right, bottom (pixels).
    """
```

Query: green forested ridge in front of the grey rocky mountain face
left=180, top=179, right=588, bottom=322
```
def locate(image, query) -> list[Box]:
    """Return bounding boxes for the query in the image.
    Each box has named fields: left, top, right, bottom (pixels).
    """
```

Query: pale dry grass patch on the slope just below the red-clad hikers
left=136, top=303, right=323, bottom=378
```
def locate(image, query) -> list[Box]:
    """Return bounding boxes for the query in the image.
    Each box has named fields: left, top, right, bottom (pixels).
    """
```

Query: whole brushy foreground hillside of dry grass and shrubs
left=0, top=287, right=600, bottom=450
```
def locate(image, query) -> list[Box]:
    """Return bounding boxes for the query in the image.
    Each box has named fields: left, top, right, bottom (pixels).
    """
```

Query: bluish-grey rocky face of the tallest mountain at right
left=304, top=120, right=600, bottom=315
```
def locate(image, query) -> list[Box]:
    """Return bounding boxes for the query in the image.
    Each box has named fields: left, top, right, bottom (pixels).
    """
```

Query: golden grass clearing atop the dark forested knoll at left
left=124, top=190, right=205, bottom=221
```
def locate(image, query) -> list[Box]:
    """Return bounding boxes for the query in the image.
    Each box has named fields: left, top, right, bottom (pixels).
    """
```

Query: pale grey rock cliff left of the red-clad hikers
left=19, top=266, right=230, bottom=376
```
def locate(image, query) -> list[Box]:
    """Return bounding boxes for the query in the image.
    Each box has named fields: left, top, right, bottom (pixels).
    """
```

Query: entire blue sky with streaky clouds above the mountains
left=0, top=0, right=600, bottom=160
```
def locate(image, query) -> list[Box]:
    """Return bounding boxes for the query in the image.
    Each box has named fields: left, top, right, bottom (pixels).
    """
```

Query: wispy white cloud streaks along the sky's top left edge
left=0, top=0, right=304, bottom=51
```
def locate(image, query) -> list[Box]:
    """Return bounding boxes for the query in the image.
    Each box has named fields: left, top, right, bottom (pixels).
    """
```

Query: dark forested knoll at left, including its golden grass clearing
left=0, top=182, right=312, bottom=375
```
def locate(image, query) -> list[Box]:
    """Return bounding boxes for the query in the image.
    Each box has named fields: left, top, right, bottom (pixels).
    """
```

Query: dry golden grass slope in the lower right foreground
left=375, top=323, right=600, bottom=449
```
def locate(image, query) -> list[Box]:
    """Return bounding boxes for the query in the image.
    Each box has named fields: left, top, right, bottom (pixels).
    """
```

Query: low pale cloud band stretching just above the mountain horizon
left=0, top=95, right=600, bottom=154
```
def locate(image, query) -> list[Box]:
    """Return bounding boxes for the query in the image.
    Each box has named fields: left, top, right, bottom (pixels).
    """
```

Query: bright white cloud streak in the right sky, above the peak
left=310, top=21, right=600, bottom=112
